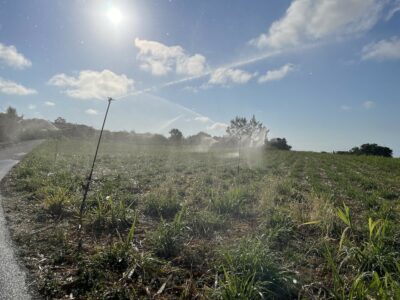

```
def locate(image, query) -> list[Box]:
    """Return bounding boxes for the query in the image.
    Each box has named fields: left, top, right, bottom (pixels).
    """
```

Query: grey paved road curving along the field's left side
left=0, top=141, right=40, bottom=300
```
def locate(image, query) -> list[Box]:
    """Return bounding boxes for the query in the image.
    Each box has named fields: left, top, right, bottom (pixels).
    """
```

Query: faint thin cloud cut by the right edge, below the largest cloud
left=362, top=36, right=400, bottom=61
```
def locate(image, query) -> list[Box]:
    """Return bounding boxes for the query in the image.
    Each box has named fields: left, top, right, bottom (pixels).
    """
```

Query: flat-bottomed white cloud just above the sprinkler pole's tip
left=48, top=70, right=134, bottom=99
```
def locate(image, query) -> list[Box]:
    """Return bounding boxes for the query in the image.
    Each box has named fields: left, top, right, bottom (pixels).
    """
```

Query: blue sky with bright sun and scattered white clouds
left=0, top=0, right=400, bottom=155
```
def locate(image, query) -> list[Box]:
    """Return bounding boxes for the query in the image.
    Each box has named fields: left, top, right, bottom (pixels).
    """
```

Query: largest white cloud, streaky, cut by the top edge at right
left=250, top=0, right=387, bottom=49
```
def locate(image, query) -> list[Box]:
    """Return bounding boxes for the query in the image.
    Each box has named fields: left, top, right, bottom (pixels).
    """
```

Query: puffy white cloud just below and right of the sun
left=135, top=38, right=206, bottom=76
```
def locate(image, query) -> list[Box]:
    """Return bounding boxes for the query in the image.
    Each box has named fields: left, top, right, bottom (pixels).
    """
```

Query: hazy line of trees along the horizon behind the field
left=0, top=107, right=393, bottom=157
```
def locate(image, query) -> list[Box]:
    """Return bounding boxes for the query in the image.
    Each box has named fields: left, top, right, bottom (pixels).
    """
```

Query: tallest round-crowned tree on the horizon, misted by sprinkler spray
left=226, top=115, right=268, bottom=146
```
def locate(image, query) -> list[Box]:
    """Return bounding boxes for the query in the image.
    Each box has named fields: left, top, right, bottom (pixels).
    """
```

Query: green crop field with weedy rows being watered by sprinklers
left=2, top=140, right=400, bottom=299
